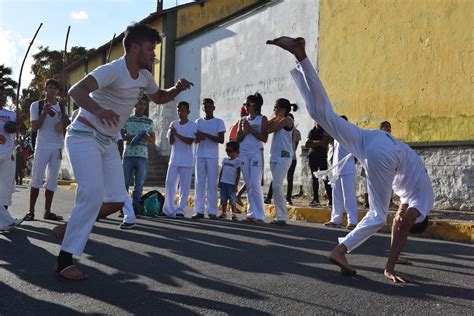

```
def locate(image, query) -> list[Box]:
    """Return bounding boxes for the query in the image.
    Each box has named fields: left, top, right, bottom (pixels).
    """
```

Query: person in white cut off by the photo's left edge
left=0, top=85, right=22, bottom=231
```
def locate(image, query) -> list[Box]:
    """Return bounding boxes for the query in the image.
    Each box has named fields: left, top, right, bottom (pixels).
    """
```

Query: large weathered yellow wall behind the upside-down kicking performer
left=319, top=0, right=474, bottom=142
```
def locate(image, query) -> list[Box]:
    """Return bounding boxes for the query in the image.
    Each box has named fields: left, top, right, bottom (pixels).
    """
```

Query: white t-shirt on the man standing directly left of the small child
left=196, top=117, right=225, bottom=159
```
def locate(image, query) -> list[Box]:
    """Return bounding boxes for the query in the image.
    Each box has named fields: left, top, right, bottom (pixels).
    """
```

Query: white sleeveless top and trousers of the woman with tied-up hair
left=270, top=119, right=294, bottom=221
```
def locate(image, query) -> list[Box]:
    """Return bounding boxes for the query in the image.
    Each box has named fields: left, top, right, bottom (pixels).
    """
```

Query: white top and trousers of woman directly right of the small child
left=239, top=115, right=265, bottom=220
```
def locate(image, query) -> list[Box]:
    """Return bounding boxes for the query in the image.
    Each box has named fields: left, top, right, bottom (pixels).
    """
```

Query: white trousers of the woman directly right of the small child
left=239, top=150, right=265, bottom=220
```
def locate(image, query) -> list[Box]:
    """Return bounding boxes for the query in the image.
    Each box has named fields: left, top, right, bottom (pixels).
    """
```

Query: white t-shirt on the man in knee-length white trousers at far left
left=30, top=101, right=68, bottom=149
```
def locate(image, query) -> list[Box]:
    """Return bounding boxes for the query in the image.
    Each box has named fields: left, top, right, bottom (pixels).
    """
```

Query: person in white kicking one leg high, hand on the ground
left=267, top=37, right=433, bottom=283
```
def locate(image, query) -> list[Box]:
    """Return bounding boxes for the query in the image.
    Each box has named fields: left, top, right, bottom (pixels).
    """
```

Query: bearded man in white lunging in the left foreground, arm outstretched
left=55, top=24, right=191, bottom=280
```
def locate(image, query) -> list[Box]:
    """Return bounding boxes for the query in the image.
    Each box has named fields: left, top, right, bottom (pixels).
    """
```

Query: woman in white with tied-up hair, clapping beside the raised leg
left=267, top=99, right=298, bottom=226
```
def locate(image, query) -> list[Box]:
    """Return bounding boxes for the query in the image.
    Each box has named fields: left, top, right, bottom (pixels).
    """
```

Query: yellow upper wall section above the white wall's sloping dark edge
left=176, top=0, right=258, bottom=38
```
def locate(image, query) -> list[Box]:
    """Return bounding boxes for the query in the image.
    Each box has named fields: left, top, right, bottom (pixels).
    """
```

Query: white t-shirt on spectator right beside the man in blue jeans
left=166, top=120, right=197, bottom=167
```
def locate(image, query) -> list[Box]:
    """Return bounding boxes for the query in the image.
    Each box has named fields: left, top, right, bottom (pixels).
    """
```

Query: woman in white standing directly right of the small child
left=237, top=92, right=268, bottom=224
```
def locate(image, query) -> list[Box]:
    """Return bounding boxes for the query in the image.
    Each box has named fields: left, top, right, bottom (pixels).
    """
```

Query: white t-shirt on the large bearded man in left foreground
left=80, top=57, right=158, bottom=137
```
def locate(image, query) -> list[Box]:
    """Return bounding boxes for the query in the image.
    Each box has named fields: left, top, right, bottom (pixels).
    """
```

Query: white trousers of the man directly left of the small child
left=194, top=158, right=219, bottom=215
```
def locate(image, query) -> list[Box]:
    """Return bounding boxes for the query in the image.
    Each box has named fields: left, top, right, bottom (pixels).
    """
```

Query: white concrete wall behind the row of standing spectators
left=175, top=0, right=319, bottom=181
